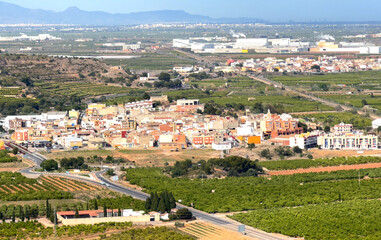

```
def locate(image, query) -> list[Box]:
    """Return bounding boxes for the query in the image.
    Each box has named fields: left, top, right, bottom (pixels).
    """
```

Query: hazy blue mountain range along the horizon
left=0, top=1, right=263, bottom=25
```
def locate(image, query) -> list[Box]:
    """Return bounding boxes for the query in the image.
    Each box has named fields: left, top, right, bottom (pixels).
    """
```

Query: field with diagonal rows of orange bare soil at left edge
left=0, top=172, right=99, bottom=201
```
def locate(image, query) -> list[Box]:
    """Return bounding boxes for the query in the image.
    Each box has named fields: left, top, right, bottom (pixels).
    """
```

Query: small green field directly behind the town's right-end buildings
left=294, top=112, right=372, bottom=129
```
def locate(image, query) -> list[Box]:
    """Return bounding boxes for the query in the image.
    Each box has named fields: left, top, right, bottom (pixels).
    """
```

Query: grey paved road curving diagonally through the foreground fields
left=20, top=162, right=290, bottom=240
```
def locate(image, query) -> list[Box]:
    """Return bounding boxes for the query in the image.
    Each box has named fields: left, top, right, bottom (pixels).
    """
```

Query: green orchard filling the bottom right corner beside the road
left=231, top=200, right=381, bottom=240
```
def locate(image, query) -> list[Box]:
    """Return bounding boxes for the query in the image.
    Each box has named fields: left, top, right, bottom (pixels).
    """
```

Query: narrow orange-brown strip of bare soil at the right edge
left=268, top=163, right=381, bottom=176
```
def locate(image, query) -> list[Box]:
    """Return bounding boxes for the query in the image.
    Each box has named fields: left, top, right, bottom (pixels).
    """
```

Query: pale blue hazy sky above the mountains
left=0, top=0, right=381, bottom=21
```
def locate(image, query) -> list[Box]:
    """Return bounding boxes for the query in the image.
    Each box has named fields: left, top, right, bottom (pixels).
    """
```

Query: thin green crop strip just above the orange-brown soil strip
left=260, top=156, right=381, bottom=170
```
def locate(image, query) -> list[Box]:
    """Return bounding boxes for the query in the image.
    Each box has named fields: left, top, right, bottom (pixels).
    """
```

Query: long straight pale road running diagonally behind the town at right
left=241, top=72, right=380, bottom=119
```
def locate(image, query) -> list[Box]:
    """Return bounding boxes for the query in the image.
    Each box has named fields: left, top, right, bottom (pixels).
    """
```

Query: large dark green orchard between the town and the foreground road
left=126, top=168, right=381, bottom=212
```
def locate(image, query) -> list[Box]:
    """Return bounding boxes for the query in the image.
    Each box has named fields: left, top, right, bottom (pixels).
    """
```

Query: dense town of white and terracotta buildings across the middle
left=1, top=95, right=380, bottom=151
